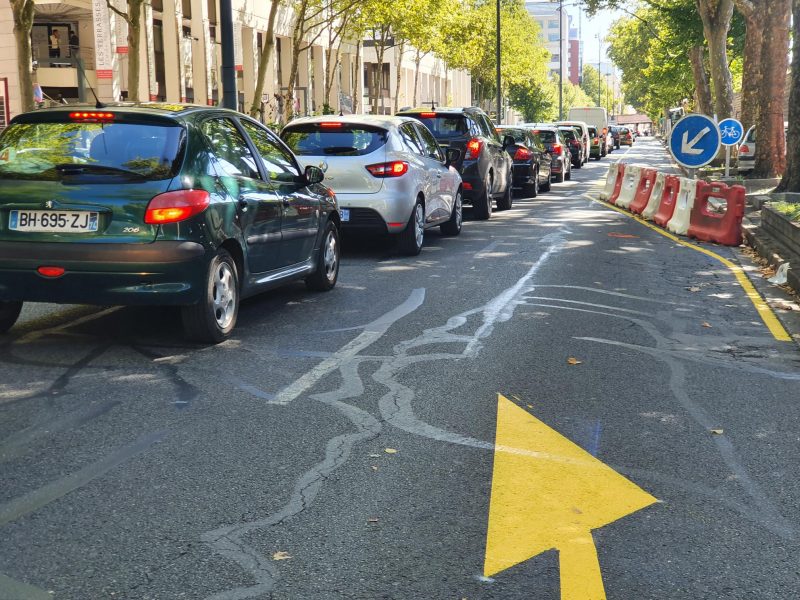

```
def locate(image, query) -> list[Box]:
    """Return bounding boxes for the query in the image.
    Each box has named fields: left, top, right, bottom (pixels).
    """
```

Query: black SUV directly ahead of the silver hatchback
left=397, top=107, right=514, bottom=219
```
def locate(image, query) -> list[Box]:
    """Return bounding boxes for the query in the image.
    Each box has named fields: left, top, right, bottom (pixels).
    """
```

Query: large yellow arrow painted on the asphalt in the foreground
left=483, top=394, right=656, bottom=600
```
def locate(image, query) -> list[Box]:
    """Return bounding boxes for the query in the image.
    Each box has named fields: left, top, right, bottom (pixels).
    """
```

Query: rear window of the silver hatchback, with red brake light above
left=281, top=123, right=389, bottom=156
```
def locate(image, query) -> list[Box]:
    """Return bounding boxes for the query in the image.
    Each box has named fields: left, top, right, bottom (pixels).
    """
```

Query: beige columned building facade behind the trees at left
left=0, top=0, right=470, bottom=127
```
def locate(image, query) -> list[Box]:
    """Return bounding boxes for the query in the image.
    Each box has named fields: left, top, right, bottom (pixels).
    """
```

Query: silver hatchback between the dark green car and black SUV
left=281, top=115, right=462, bottom=256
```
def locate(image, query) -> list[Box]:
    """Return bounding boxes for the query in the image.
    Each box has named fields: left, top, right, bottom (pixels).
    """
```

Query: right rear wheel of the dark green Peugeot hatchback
left=181, top=249, right=239, bottom=344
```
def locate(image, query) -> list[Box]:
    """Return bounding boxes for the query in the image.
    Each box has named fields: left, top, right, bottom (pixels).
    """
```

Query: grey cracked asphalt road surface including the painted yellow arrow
left=0, top=140, right=800, bottom=600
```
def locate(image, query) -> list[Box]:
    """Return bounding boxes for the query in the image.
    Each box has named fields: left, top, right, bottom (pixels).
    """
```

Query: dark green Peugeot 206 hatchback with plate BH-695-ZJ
left=0, top=104, right=340, bottom=343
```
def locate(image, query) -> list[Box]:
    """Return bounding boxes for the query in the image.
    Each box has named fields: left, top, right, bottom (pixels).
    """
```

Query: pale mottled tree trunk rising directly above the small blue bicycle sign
left=695, top=0, right=733, bottom=121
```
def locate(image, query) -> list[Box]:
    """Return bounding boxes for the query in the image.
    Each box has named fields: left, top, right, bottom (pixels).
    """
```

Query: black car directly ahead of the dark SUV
left=497, top=125, right=552, bottom=198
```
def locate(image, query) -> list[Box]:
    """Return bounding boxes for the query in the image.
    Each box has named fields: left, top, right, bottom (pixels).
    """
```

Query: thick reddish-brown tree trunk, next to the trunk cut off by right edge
left=753, top=0, right=791, bottom=178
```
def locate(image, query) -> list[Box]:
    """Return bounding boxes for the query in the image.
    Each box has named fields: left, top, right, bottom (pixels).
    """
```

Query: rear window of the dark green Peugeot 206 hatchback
left=0, top=122, right=184, bottom=180
